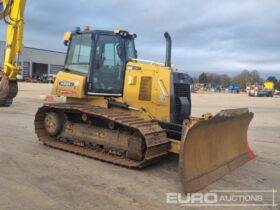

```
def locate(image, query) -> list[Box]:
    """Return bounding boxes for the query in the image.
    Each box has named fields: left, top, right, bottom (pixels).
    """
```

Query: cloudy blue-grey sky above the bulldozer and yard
left=0, top=0, right=280, bottom=73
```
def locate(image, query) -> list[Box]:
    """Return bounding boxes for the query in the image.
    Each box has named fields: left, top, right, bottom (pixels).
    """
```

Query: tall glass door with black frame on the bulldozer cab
left=87, top=34, right=125, bottom=96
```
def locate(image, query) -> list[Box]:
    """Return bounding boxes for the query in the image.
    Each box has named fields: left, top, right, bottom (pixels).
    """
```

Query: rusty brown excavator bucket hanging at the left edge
left=0, top=74, right=18, bottom=106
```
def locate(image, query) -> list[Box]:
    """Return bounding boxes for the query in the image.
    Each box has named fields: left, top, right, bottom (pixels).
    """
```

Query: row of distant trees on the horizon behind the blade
left=192, top=70, right=280, bottom=90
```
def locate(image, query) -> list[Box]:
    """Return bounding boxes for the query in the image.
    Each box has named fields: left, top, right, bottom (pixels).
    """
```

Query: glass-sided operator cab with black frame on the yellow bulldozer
left=64, top=30, right=137, bottom=96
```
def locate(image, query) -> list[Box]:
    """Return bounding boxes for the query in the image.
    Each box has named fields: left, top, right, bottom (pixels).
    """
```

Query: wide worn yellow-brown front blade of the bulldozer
left=179, top=108, right=254, bottom=193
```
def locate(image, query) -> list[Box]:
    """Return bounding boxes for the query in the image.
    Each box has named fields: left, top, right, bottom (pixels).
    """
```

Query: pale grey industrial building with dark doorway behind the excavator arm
left=0, top=41, right=66, bottom=79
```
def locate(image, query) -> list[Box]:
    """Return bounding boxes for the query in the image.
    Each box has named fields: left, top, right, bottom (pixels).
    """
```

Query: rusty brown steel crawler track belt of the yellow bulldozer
left=34, top=103, right=170, bottom=168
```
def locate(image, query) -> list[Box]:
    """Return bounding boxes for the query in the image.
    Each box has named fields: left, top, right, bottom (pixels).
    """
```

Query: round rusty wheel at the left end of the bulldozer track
left=44, top=112, right=63, bottom=136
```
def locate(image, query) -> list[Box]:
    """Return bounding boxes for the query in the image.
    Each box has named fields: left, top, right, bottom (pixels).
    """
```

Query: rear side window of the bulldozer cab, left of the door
left=65, top=34, right=92, bottom=74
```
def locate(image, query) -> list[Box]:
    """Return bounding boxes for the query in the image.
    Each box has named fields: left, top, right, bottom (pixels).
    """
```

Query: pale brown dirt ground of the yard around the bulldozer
left=0, top=83, right=280, bottom=210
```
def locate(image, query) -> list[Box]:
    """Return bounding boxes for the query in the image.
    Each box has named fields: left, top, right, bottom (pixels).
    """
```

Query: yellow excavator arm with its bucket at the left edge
left=0, top=0, right=26, bottom=106
